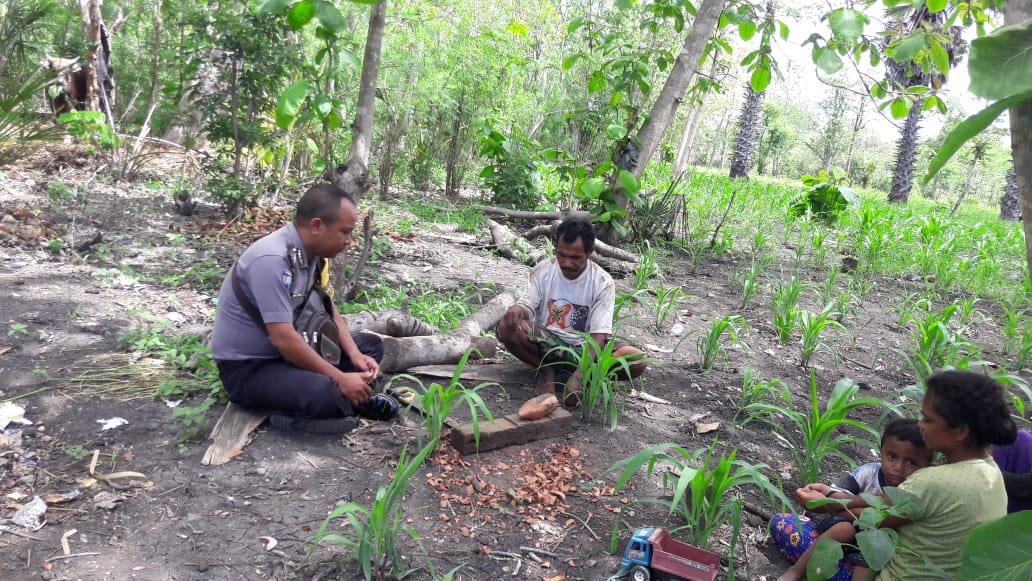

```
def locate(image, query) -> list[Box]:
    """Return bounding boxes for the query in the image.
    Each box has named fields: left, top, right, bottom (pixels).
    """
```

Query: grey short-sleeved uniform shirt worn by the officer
left=212, top=224, right=316, bottom=361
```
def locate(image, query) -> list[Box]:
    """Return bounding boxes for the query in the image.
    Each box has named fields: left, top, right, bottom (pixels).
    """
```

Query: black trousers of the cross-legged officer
left=217, top=332, right=384, bottom=418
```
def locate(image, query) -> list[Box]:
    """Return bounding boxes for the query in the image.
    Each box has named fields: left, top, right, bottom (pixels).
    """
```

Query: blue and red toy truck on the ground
left=617, top=528, right=720, bottom=581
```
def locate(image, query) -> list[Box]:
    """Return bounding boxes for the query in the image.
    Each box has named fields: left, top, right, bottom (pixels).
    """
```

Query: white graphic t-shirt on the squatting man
left=518, top=258, right=616, bottom=346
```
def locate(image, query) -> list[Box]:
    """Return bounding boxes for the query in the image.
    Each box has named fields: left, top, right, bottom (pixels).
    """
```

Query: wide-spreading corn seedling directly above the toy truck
left=599, top=440, right=788, bottom=550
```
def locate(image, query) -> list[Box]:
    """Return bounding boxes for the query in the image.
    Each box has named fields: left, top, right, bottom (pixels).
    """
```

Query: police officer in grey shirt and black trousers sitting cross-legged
left=212, top=185, right=397, bottom=433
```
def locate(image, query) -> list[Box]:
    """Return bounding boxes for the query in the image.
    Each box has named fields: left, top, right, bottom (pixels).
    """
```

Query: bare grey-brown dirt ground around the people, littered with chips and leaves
left=0, top=148, right=1015, bottom=581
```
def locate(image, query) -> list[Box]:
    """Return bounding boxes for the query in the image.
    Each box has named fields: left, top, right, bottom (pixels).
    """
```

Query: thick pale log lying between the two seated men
left=380, top=292, right=516, bottom=374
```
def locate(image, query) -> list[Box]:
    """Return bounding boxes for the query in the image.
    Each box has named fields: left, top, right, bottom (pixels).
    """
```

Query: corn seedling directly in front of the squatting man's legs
left=549, top=333, right=652, bottom=430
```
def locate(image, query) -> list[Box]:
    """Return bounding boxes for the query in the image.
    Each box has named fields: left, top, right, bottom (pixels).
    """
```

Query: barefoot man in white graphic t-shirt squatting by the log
left=496, top=219, right=647, bottom=407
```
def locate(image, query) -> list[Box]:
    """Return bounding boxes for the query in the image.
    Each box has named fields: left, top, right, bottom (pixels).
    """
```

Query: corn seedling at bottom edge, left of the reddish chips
left=309, top=440, right=438, bottom=581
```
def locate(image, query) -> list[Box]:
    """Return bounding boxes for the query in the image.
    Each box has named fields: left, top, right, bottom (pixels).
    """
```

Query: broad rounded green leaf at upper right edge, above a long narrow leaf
left=968, top=19, right=1032, bottom=99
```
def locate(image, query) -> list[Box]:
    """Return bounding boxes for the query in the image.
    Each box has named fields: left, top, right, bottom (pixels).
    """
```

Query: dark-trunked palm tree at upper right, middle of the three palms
left=884, top=3, right=967, bottom=202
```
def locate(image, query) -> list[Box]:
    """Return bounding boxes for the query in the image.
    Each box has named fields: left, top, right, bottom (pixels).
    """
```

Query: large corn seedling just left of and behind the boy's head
left=745, top=370, right=891, bottom=483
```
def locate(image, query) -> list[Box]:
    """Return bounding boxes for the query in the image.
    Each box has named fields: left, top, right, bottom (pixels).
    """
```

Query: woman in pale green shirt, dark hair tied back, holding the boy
left=772, top=370, right=1018, bottom=581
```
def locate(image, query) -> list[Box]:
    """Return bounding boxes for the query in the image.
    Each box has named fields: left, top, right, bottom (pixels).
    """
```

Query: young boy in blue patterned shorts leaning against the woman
left=770, top=418, right=932, bottom=581
